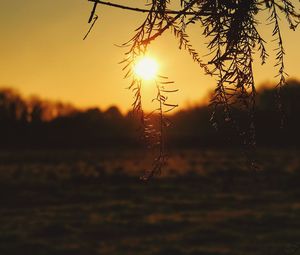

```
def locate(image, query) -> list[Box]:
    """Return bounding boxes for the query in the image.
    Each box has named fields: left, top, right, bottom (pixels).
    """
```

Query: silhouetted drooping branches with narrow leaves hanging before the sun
left=86, top=0, right=300, bottom=179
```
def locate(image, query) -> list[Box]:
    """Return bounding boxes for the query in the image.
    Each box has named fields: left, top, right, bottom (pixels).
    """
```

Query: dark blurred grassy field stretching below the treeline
left=0, top=147, right=300, bottom=255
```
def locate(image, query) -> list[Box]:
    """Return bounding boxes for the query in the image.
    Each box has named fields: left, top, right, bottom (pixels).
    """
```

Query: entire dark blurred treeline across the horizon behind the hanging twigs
left=0, top=80, right=300, bottom=149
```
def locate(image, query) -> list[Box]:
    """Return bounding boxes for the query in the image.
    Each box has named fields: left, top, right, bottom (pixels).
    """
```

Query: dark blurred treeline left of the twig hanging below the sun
left=0, top=89, right=139, bottom=148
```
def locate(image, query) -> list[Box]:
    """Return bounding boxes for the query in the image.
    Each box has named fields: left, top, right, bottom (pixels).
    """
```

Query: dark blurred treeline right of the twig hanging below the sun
left=169, top=80, right=300, bottom=147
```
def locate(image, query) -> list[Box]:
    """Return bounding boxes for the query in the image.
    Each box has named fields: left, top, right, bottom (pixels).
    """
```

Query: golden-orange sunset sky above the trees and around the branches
left=0, top=0, right=300, bottom=112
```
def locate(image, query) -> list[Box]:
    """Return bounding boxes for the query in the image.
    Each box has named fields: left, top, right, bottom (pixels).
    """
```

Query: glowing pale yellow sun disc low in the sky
left=134, top=57, right=158, bottom=80
